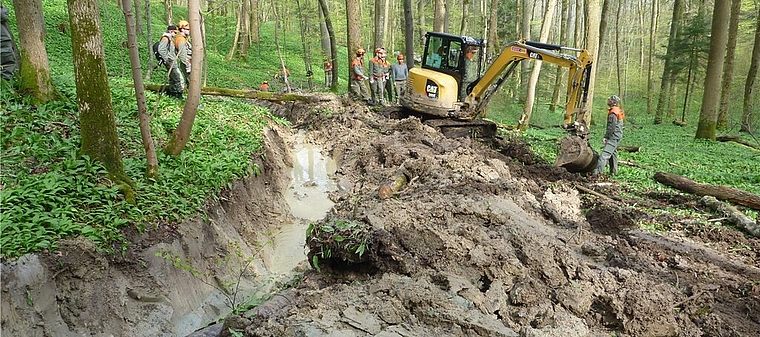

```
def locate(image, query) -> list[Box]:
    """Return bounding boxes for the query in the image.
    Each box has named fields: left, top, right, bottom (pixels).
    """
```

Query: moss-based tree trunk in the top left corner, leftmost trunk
left=13, top=0, right=57, bottom=103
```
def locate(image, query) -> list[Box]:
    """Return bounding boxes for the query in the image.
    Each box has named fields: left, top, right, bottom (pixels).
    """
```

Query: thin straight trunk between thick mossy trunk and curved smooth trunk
left=121, top=0, right=158, bottom=179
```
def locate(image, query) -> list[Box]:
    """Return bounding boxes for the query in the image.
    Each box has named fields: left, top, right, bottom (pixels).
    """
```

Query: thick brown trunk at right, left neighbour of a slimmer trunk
left=695, top=0, right=731, bottom=140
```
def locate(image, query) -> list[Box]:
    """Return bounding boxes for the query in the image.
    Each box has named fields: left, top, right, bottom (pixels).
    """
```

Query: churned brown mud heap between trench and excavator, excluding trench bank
left=222, top=99, right=760, bottom=336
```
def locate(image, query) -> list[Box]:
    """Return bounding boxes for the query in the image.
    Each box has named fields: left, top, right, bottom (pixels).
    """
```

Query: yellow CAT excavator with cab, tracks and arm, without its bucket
left=399, top=32, right=593, bottom=136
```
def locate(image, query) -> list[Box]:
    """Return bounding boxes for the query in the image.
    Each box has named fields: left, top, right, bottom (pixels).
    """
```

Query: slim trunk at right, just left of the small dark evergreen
left=654, top=0, right=684, bottom=124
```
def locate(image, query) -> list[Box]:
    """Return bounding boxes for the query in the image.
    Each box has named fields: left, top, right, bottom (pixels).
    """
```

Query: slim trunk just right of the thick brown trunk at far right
left=715, top=0, right=742, bottom=130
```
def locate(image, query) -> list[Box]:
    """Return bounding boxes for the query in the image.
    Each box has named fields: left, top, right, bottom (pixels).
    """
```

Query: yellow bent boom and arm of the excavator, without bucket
left=464, top=40, right=593, bottom=126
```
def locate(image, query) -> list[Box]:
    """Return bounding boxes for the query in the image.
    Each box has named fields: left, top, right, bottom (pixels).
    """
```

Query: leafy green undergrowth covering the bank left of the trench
left=0, top=78, right=285, bottom=258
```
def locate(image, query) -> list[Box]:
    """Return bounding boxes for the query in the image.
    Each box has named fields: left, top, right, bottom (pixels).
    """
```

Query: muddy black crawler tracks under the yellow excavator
left=380, top=106, right=497, bottom=138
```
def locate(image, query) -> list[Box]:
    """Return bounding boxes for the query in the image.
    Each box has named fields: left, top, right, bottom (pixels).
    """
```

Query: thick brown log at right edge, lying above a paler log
left=654, top=172, right=760, bottom=210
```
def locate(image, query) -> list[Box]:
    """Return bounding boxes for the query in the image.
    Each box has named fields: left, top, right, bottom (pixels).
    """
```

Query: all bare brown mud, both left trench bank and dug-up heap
left=2, top=95, right=760, bottom=336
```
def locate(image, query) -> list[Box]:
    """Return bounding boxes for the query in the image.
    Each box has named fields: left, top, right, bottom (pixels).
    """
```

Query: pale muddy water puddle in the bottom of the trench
left=263, top=132, right=337, bottom=275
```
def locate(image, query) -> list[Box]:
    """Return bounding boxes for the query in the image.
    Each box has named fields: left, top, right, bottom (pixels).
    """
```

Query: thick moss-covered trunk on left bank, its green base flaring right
left=68, top=0, right=134, bottom=194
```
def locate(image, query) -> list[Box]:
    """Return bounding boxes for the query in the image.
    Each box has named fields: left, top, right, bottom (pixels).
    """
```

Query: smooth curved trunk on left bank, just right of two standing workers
left=163, top=0, right=206, bottom=156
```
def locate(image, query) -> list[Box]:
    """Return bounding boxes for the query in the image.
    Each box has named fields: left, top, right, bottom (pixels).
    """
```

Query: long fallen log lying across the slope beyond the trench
left=127, top=84, right=338, bottom=103
